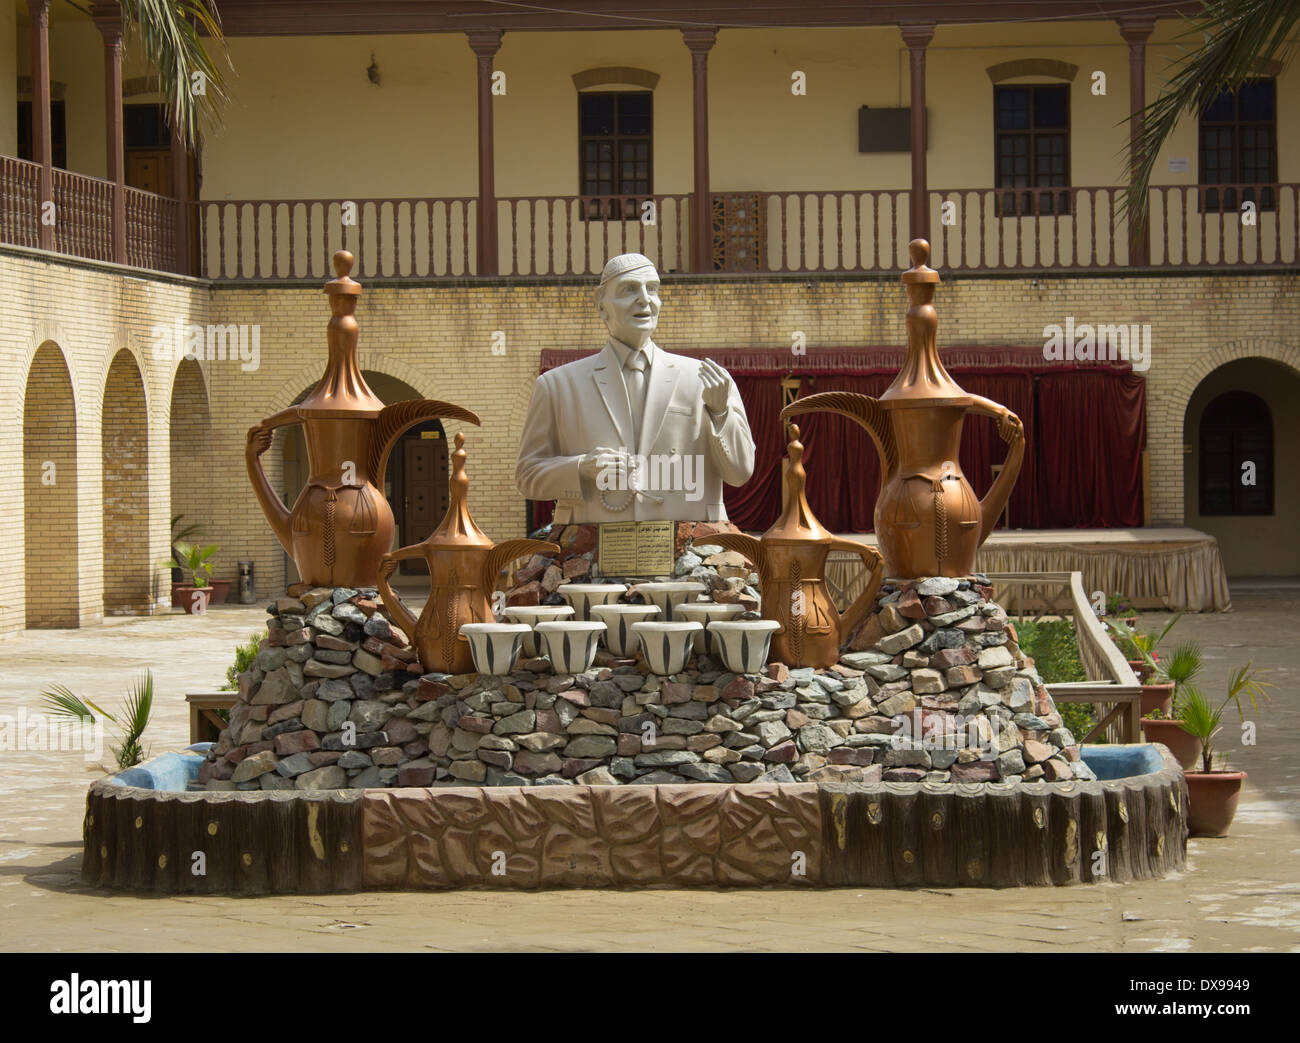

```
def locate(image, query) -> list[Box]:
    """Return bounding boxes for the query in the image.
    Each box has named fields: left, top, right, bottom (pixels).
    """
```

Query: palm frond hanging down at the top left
left=118, top=0, right=230, bottom=148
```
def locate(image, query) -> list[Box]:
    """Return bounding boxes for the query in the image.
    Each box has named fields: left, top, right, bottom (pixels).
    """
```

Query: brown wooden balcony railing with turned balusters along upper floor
left=0, top=157, right=1300, bottom=282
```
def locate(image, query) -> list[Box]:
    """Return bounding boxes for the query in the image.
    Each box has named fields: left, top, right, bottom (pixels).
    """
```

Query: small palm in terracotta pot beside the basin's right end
left=1179, top=663, right=1271, bottom=836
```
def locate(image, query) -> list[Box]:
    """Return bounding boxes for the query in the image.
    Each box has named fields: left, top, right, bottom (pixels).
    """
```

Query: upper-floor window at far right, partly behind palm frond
left=1199, top=79, right=1278, bottom=211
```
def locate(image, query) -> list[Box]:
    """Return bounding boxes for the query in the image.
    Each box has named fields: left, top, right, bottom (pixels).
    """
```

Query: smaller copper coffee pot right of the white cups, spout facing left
left=707, top=424, right=884, bottom=670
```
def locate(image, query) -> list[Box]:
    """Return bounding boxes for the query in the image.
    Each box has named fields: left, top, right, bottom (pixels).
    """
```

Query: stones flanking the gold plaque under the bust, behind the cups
left=506, top=522, right=758, bottom=611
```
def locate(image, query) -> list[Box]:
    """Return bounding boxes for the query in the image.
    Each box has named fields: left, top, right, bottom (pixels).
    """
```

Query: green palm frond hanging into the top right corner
left=1123, top=0, right=1300, bottom=221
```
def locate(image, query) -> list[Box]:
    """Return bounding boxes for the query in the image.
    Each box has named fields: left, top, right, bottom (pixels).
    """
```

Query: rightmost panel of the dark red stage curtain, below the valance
left=1029, top=369, right=1147, bottom=528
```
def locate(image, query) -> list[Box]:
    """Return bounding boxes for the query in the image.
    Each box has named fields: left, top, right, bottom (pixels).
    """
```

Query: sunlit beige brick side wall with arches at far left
left=0, top=248, right=209, bottom=635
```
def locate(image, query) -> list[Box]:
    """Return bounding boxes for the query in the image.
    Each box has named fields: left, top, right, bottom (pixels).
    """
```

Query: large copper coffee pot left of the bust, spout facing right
left=244, top=250, right=478, bottom=590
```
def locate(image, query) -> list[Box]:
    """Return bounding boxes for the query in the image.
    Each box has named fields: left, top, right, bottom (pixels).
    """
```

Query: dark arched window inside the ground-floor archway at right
left=1199, top=391, right=1273, bottom=515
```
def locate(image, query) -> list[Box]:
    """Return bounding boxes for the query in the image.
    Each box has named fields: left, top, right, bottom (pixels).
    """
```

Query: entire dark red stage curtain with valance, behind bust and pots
left=533, top=347, right=1147, bottom=532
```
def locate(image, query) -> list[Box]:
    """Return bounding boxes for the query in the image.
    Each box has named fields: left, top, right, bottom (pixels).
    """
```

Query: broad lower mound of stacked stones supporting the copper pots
left=199, top=576, right=1092, bottom=789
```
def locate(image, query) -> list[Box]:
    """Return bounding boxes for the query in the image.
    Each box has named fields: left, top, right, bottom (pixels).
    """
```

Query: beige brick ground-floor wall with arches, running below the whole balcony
left=0, top=244, right=1300, bottom=632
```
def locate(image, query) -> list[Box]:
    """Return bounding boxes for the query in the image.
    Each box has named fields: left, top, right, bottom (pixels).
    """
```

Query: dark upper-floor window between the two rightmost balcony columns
left=993, top=83, right=1070, bottom=217
